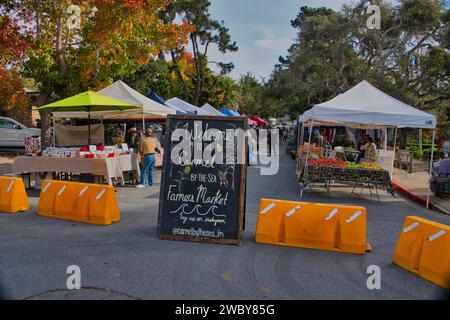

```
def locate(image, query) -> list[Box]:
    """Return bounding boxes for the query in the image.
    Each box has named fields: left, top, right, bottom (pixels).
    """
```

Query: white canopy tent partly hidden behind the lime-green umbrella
left=53, top=80, right=176, bottom=127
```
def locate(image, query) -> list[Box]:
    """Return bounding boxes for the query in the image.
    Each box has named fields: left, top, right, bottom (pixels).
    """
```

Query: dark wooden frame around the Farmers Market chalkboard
left=157, top=115, right=248, bottom=245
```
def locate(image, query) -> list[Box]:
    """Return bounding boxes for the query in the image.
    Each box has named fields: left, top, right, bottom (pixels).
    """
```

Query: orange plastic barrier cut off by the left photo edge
left=0, top=177, right=30, bottom=213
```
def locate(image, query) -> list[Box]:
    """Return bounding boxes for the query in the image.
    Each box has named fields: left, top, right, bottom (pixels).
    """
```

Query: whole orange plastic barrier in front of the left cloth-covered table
left=38, top=180, right=120, bottom=225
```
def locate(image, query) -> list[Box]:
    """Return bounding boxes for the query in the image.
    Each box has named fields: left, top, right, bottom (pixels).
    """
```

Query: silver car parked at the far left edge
left=0, top=117, right=41, bottom=148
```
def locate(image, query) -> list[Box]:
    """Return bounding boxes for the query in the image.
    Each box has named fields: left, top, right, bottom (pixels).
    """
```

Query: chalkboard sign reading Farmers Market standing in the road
left=158, top=115, right=247, bottom=244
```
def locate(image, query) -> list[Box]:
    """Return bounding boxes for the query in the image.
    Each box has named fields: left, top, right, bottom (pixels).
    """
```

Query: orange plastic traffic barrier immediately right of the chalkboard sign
left=255, top=199, right=371, bottom=254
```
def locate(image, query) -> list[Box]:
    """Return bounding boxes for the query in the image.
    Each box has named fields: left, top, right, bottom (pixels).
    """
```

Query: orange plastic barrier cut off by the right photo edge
left=393, top=216, right=450, bottom=290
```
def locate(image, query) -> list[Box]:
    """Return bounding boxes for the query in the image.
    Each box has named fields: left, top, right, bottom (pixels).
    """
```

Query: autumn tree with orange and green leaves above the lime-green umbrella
left=0, top=0, right=193, bottom=145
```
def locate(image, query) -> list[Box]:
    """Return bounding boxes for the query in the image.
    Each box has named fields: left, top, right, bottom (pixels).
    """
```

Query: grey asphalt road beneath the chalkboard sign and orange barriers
left=0, top=151, right=450, bottom=299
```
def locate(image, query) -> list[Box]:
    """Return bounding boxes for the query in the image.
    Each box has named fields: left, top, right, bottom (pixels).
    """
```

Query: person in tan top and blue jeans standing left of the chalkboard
left=136, top=129, right=159, bottom=189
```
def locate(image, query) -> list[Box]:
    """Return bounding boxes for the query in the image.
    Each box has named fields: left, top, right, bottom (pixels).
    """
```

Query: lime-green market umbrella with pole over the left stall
left=38, top=91, right=138, bottom=145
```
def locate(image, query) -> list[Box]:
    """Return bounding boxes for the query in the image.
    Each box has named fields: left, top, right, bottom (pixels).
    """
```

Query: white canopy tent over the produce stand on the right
left=299, top=80, right=436, bottom=208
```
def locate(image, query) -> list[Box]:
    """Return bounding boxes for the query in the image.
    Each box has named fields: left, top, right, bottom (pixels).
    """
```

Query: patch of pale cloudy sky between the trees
left=209, top=0, right=450, bottom=79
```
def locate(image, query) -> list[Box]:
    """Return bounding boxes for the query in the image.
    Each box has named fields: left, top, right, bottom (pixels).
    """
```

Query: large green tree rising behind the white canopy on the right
left=262, top=0, right=450, bottom=141
